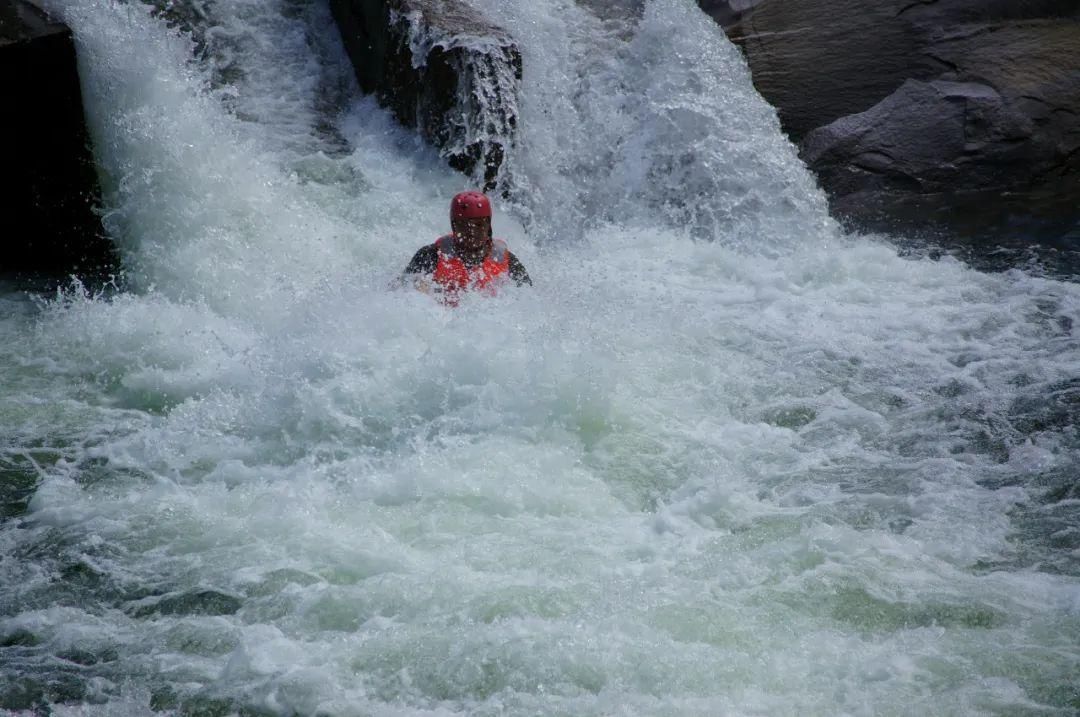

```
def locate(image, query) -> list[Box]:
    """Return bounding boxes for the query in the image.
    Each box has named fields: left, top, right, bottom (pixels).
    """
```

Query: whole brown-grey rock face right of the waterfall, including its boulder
left=700, top=0, right=1080, bottom=239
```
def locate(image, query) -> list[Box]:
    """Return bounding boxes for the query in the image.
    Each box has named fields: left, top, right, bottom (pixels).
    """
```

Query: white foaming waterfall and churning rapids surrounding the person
left=0, top=0, right=1080, bottom=715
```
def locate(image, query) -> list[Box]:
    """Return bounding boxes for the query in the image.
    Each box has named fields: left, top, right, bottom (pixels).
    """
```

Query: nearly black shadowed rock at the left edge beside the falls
left=0, top=0, right=114, bottom=273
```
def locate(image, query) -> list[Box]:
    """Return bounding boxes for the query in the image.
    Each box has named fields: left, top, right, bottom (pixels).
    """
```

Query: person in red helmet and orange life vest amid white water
left=399, top=191, right=532, bottom=306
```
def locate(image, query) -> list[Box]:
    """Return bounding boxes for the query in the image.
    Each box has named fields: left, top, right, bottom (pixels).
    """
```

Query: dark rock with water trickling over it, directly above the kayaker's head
left=330, top=0, right=522, bottom=189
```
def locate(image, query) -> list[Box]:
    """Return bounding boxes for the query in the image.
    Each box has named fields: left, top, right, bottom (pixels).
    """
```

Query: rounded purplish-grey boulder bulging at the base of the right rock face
left=801, top=80, right=1080, bottom=234
